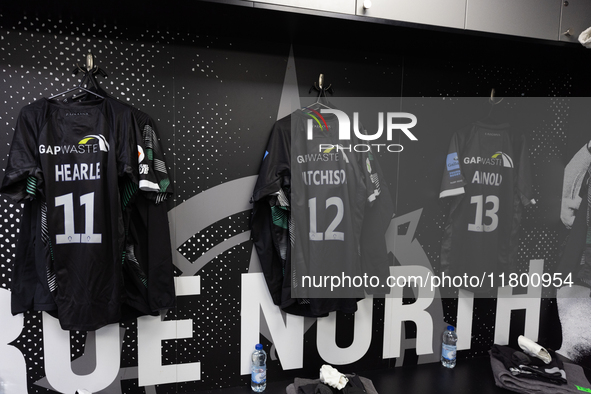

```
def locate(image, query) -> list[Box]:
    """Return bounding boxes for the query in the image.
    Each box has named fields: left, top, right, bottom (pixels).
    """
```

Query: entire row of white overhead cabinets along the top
left=252, top=0, right=591, bottom=42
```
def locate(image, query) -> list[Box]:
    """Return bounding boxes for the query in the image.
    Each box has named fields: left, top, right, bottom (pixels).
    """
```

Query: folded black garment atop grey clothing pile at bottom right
left=490, top=345, right=567, bottom=385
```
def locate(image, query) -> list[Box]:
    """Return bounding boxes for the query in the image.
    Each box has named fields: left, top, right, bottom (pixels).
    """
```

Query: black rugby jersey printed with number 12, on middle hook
left=251, top=110, right=393, bottom=316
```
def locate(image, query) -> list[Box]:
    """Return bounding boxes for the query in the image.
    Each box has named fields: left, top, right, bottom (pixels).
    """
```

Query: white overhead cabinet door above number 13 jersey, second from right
left=466, top=0, right=560, bottom=40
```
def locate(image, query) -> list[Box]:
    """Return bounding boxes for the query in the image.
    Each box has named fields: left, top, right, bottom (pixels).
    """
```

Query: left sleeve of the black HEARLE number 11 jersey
left=0, top=106, right=43, bottom=202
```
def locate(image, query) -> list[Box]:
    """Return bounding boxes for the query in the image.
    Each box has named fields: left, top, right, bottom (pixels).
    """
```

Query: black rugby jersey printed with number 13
left=440, top=122, right=533, bottom=292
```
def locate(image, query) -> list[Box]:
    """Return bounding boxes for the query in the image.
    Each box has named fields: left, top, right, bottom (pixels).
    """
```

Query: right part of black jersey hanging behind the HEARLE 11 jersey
left=120, top=108, right=175, bottom=319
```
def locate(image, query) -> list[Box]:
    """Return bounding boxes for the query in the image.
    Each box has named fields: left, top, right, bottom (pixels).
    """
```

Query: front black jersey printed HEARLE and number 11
left=0, top=98, right=173, bottom=330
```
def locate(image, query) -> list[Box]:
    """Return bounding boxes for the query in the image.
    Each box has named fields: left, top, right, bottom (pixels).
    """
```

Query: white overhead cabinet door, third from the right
left=357, top=0, right=470, bottom=29
